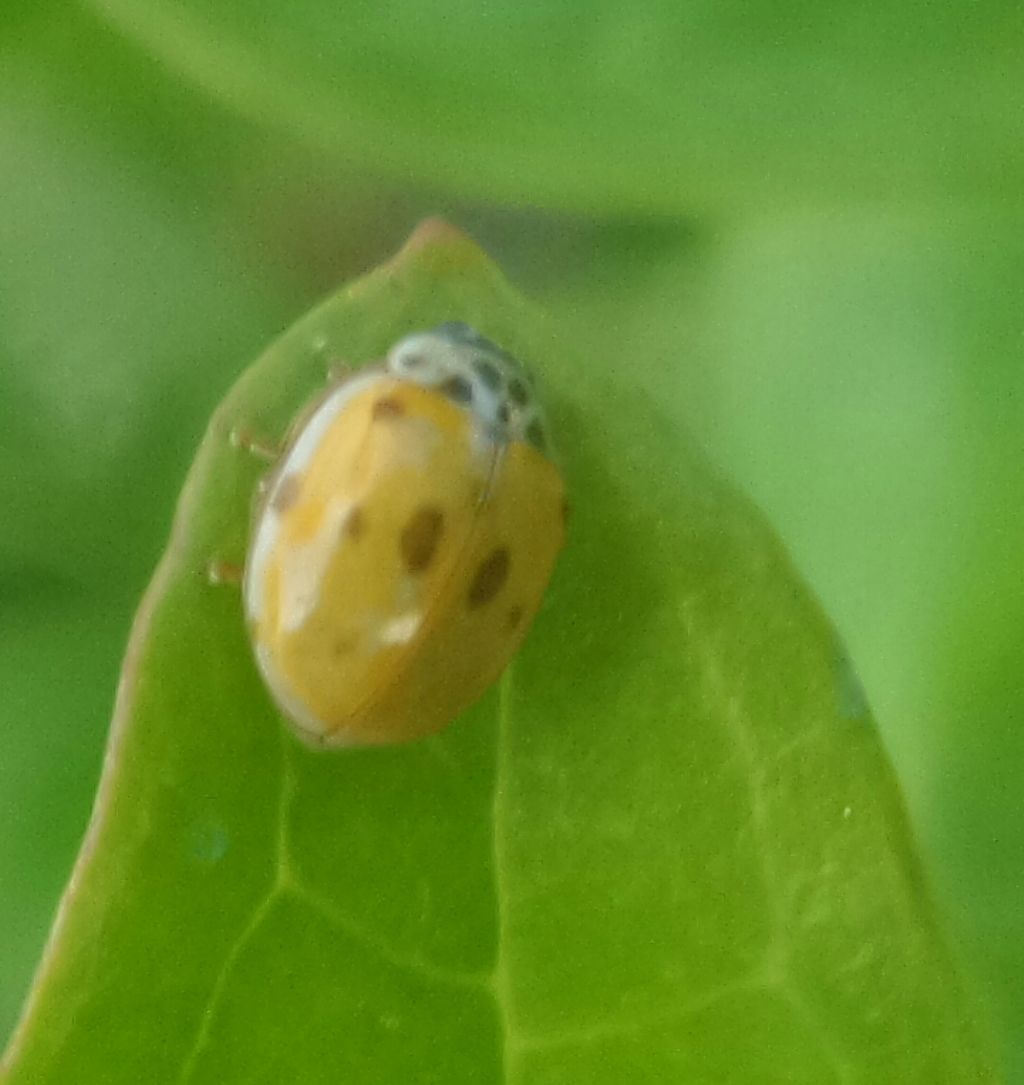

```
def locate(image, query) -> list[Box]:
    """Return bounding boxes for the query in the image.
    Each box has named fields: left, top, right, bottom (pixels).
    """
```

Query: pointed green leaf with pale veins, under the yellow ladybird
left=3, top=222, right=995, bottom=1085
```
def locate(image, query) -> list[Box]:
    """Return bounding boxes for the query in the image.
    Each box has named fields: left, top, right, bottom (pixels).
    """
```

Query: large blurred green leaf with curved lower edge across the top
left=91, top=0, right=1024, bottom=213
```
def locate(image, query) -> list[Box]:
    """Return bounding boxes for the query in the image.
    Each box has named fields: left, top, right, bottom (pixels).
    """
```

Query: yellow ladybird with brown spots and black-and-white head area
left=243, top=323, right=565, bottom=745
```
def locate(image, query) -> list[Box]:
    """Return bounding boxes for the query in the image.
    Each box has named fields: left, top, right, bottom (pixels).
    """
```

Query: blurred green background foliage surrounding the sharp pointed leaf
left=0, top=0, right=1024, bottom=1081
